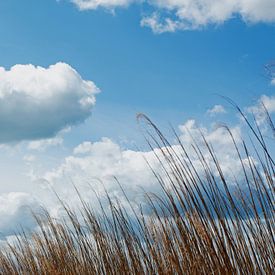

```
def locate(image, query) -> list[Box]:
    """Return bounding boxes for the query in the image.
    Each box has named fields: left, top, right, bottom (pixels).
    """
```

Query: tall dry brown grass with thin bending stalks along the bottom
left=0, top=106, right=275, bottom=275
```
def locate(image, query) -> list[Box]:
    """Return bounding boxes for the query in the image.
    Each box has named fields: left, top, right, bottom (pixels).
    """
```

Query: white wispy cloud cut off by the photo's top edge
left=71, top=0, right=275, bottom=33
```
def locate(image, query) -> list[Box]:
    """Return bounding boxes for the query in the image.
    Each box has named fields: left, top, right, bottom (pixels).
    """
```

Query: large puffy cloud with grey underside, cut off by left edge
left=0, top=63, right=99, bottom=143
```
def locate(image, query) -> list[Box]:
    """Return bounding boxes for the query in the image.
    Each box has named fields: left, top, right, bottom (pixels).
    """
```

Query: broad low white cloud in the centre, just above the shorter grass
left=43, top=138, right=163, bottom=213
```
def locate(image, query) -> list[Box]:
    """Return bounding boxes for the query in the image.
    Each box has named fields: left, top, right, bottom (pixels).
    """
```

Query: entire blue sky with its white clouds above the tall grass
left=0, top=0, right=275, bottom=239
